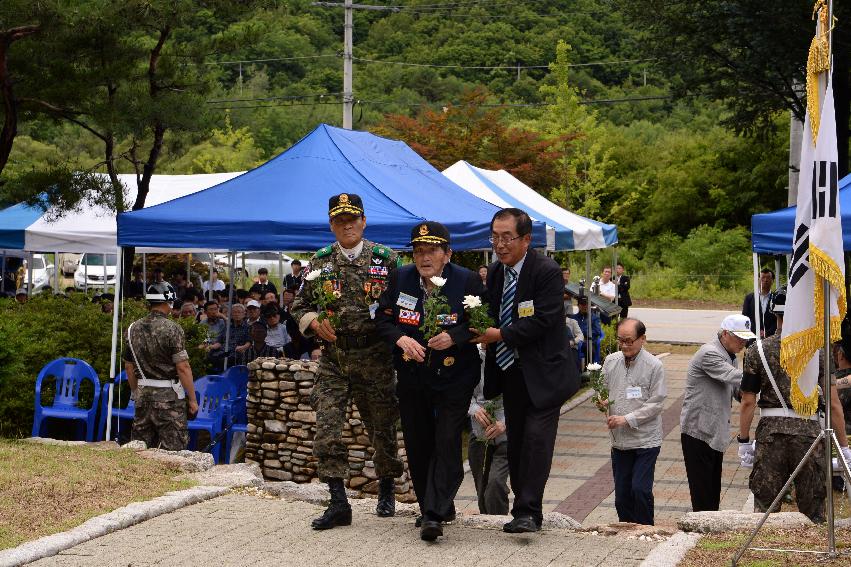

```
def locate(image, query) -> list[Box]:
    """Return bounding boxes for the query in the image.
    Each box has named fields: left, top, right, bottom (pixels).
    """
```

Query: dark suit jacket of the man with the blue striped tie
left=484, top=249, right=579, bottom=408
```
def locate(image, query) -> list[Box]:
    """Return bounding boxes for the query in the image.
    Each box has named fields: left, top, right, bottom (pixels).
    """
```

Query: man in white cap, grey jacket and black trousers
left=680, top=315, right=756, bottom=512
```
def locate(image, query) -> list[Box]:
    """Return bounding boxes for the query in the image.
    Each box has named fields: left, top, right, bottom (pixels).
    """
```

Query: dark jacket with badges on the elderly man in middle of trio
left=375, top=263, right=484, bottom=397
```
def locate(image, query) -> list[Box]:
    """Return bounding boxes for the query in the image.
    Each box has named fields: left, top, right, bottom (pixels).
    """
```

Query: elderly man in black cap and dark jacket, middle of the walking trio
left=375, top=221, right=484, bottom=541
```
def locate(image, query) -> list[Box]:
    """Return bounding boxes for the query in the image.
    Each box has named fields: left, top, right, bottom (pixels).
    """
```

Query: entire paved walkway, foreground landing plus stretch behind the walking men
left=25, top=355, right=749, bottom=567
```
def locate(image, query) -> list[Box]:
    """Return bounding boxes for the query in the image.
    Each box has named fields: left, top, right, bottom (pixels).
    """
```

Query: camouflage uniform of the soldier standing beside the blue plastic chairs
left=124, top=311, right=189, bottom=451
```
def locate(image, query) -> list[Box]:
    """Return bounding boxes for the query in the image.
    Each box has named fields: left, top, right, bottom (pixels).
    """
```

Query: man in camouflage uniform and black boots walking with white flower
left=291, top=193, right=402, bottom=529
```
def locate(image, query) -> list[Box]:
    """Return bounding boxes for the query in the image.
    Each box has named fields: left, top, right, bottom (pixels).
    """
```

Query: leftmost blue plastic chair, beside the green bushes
left=32, top=358, right=100, bottom=441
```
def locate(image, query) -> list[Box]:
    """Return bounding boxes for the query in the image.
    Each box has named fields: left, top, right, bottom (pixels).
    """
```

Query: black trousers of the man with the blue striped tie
left=503, top=362, right=561, bottom=526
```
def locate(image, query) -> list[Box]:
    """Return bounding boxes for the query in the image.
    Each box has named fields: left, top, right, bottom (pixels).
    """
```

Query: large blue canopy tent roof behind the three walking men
left=118, top=124, right=546, bottom=251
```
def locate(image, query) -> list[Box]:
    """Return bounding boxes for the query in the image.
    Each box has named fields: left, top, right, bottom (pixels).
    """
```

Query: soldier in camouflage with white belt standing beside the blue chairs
left=124, top=282, right=198, bottom=451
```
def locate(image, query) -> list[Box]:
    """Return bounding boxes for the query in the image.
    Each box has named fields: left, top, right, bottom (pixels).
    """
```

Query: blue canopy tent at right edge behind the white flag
left=751, top=175, right=851, bottom=254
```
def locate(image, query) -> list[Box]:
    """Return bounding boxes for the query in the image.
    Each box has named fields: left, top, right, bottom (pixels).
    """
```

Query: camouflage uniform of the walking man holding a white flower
left=290, top=239, right=402, bottom=481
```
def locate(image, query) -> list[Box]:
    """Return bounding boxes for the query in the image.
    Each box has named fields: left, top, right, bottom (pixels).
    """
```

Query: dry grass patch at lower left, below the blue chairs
left=0, top=439, right=194, bottom=549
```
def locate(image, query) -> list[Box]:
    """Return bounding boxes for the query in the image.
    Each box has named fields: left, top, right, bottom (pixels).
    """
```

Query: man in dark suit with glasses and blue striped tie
left=477, top=208, right=579, bottom=533
